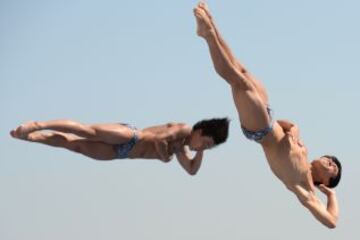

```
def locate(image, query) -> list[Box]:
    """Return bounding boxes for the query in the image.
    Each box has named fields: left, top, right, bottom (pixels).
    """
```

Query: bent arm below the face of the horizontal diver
left=176, top=147, right=203, bottom=175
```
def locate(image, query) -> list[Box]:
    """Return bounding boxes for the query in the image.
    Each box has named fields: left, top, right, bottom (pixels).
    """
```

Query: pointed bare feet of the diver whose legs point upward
left=194, top=2, right=215, bottom=38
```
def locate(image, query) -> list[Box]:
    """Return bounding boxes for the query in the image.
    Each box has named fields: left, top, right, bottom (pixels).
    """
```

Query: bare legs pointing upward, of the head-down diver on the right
left=194, top=4, right=270, bottom=131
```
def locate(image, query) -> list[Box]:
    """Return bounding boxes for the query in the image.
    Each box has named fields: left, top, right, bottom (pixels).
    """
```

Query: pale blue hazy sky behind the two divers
left=0, top=0, right=360, bottom=240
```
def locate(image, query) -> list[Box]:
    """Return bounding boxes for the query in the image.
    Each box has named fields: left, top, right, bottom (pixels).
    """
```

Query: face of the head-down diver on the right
left=312, top=157, right=339, bottom=185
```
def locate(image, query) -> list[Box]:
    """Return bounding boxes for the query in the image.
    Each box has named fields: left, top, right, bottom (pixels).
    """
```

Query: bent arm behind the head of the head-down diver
left=296, top=185, right=339, bottom=228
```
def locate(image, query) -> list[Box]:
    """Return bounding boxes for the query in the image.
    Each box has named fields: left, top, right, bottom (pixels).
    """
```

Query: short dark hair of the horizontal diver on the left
left=192, top=118, right=230, bottom=145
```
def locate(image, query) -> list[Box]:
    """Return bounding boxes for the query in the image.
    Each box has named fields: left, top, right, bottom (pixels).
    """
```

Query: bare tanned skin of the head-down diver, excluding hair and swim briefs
left=194, top=2, right=339, bottom=228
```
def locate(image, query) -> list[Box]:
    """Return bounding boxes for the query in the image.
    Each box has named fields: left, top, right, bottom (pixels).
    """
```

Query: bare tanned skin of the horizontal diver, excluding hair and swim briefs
left=10, top=120, right=214, bottom=175
